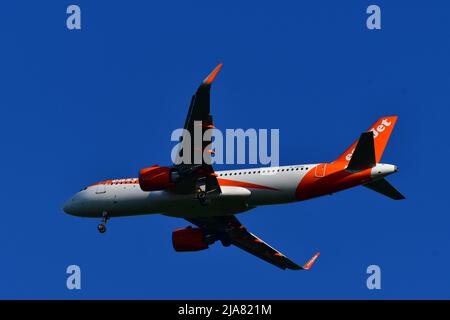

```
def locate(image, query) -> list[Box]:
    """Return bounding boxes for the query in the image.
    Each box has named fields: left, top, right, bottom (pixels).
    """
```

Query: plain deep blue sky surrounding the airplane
left=0, top=1, right=450, bottom=299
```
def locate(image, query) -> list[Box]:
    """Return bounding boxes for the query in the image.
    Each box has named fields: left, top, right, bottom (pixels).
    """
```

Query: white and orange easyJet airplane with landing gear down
left=63, top=64, right=405, bottom=270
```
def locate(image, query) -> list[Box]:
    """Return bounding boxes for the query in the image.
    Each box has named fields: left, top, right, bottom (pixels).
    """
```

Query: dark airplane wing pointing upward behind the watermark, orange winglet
left=171, top=64, right=222, bottom=193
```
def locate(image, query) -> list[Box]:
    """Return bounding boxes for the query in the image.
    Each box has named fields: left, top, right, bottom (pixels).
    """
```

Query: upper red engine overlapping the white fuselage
left=139, top=165, right=175, bottom=191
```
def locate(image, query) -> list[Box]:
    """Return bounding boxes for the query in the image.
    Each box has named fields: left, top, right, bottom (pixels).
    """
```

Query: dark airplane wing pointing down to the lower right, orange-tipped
left=186, top=215, right=320, bottom=270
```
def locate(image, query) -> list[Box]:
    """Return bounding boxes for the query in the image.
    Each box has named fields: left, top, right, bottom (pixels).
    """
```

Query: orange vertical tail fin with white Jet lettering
left=335, top=116, right=397, bottom=163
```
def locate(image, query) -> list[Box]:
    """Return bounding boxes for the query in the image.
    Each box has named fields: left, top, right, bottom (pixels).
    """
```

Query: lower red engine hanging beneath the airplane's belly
left=172, top=226, right=208, bottom=251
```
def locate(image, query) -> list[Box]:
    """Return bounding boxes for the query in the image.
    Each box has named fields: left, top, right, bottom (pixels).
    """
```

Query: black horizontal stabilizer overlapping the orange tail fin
left=346, top=132, right=376, bottom=171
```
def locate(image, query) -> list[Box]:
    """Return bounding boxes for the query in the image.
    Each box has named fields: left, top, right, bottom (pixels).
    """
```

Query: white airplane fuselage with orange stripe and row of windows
left=64, top=164, right=396, bottom=217
